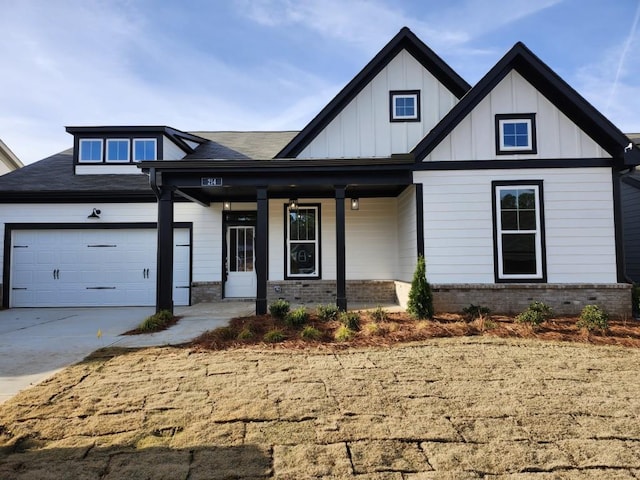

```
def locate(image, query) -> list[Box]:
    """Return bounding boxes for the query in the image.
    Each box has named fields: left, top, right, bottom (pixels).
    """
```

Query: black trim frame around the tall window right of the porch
left=491, top=180, right=547, bottom=283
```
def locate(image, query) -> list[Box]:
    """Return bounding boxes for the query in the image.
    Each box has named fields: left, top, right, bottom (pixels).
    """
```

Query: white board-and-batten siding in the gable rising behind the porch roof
left=298, top=50, right=458, bottom=158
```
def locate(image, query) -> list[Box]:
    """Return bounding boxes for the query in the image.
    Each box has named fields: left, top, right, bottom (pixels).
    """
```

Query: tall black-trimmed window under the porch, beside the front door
left=285, top=206, right=320, bottom=278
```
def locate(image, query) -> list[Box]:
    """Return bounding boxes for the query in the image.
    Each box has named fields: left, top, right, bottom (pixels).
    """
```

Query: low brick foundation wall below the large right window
left=424, top=283, right=631, bottom=317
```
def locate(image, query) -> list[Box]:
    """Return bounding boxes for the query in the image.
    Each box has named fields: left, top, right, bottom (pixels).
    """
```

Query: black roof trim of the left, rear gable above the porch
left=276, top=27, right=471, bottom=158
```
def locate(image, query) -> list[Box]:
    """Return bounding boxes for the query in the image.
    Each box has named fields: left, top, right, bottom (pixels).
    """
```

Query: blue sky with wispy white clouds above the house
left=0, top=0, right=640, bottom=164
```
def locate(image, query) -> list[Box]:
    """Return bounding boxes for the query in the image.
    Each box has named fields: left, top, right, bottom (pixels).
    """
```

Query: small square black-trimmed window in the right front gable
left=496, top=113, right=536, bottom=155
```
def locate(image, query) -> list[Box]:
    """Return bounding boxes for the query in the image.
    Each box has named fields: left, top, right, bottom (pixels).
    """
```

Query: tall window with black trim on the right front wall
left=493, top=181, right=546, bottom=282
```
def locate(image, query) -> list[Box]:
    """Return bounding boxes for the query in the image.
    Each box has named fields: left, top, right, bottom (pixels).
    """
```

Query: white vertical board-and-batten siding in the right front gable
left=425, top=71, right=610, bottom=162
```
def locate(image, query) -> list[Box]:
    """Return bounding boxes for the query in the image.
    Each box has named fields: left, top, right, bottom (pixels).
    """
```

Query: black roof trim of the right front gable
left=412, top=42, right=640, bottom=169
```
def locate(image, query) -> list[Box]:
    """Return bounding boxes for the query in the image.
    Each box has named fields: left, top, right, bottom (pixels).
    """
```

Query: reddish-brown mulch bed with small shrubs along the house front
left=192, top=312, right=640, bottom=350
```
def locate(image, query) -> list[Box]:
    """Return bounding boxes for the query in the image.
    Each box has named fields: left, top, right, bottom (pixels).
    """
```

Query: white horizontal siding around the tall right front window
left=414, top=168, right=616, bottom=283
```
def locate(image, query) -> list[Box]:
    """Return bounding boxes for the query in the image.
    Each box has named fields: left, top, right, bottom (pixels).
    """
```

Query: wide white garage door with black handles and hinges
left=10, top=228, right=191, bottom=307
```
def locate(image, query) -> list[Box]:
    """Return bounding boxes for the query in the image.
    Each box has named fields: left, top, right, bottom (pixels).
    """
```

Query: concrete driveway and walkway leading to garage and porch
left=0, top=302, right=255, bottom=403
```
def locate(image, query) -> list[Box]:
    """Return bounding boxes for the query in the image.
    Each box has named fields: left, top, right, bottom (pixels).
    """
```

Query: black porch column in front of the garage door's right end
left=156, top=187, right=173, bottom=313
